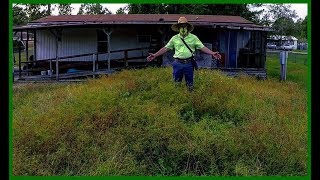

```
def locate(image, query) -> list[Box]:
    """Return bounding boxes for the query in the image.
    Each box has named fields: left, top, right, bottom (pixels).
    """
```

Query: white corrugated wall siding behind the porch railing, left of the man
left=37, top=28, right=149, bottom=61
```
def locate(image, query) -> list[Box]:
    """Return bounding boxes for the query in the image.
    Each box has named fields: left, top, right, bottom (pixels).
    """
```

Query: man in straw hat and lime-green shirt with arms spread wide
left=147, top=17, right=221, bottom=91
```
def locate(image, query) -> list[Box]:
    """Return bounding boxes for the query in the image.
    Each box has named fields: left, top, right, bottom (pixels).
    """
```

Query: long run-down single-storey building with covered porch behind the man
left=13, top=14, right=270, bottom=80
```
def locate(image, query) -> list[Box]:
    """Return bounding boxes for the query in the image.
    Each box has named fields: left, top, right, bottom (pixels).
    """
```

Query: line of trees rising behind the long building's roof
left=12, top=3, right=307, bottom=41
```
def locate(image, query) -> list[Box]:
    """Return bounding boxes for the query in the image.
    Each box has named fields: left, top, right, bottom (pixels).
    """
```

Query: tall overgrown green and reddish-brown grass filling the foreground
left=12, top=65, right=308, bottom=176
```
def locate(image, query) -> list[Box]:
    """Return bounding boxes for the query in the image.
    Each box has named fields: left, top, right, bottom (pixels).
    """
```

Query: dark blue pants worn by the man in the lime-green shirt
left=172, top=61, right=193, bottom=90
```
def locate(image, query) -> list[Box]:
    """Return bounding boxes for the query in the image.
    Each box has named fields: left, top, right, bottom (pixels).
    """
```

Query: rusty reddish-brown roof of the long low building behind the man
left=13, top=14, right=269, bottom=31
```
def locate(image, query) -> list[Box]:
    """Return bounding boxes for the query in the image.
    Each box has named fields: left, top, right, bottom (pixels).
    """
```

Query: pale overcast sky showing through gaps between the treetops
left=53, top=3, right=308, bottom=19
